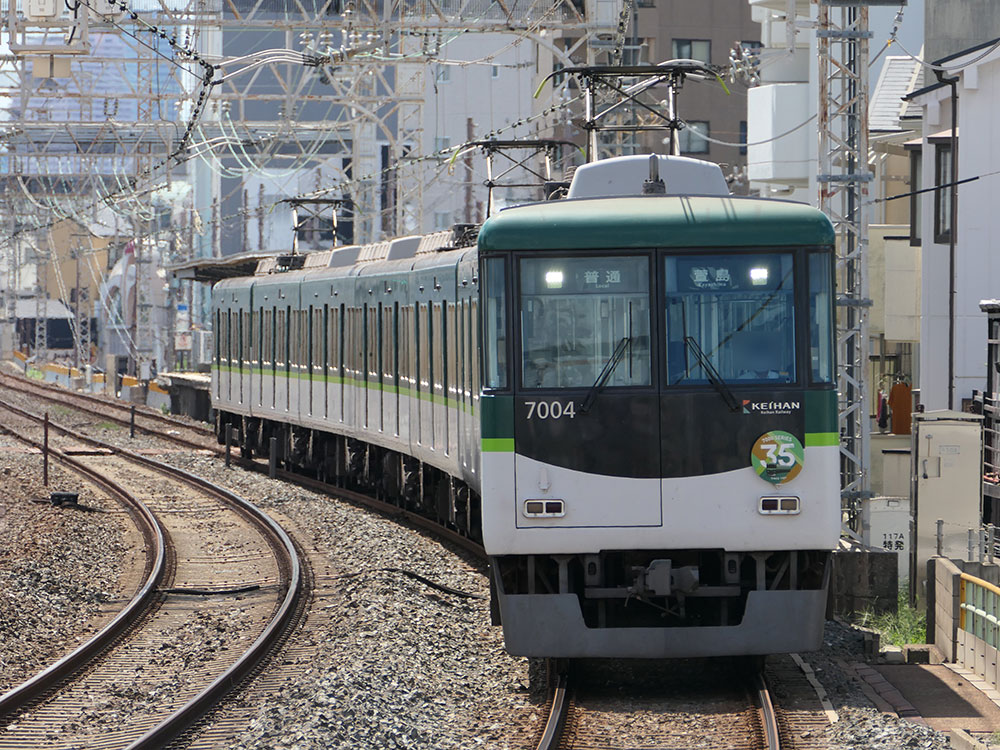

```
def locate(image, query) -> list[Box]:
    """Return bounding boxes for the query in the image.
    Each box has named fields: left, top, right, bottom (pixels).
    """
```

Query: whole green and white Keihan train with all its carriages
left=212, top=156, right=840, bottom=658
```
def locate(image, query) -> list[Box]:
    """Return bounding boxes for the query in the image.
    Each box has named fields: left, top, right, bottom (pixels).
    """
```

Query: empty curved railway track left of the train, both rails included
left=0, top=401, right=303, bottom=749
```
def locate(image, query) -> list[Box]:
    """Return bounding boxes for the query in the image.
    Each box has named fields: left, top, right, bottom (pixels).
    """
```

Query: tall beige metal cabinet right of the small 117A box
left=910, top=410, right=983, bottom=602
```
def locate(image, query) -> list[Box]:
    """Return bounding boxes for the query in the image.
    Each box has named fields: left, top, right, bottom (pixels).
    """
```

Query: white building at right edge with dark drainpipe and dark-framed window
left=909, top=40, right=1000, bottom=409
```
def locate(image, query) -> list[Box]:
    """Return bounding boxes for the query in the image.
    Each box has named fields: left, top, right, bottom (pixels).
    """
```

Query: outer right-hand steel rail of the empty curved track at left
left=0, top=401, right=303, bottom=750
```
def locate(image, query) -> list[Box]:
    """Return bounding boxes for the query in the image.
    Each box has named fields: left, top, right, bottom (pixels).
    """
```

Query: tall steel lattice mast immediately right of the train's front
left=816, top=0, right=873, bottom=533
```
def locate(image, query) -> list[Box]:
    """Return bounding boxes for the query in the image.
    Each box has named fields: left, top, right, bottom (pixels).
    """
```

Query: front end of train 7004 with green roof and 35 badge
left=479, top=157, right=840, bottom=658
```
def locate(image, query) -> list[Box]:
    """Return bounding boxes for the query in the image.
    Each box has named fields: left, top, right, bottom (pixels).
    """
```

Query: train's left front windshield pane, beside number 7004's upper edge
left=519, top=256, right=651, bottom=388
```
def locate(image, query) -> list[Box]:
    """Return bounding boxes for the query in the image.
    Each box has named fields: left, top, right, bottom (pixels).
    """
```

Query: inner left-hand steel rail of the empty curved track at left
left=0, top=408, right=167, bottom=717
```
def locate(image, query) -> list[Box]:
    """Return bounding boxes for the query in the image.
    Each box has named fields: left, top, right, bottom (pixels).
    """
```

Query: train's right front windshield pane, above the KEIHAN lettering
left=666, top=253, right=796, bottom=385
